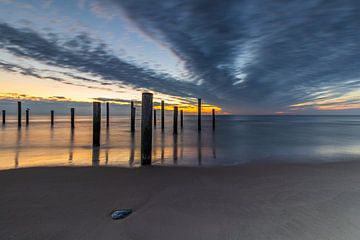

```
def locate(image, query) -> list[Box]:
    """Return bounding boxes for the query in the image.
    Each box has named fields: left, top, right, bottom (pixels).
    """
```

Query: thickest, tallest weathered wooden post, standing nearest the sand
left=141, top=93, right=153, bottom=165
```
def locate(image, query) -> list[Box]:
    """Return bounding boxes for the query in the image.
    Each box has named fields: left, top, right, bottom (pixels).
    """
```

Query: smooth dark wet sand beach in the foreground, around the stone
left=0, top=162, right=360, bottom=240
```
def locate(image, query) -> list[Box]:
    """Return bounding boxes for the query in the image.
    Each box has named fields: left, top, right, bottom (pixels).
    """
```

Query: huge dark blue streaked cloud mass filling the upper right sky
left=111, top=0, right=360, bottom=111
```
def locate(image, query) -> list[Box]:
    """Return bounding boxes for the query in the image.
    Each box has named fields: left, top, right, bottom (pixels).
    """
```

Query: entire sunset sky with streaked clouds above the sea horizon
left=0, top=0, right=360, bottom=114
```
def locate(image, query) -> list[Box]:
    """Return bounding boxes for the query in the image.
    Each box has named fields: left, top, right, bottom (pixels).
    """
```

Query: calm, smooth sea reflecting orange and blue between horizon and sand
left=0, top=116, right=360, bottom=169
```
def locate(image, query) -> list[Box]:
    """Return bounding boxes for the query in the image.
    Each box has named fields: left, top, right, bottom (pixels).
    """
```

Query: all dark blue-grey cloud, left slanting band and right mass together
left=0, top=0, right=360, bottom=113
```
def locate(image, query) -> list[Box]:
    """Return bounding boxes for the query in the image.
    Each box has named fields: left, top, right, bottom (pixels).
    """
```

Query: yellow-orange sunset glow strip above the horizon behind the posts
left=0, top=71, right=222, bottom=113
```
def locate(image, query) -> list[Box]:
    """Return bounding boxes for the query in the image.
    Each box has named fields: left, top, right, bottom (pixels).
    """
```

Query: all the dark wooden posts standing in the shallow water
left=2, top=93, right=215, bottom=165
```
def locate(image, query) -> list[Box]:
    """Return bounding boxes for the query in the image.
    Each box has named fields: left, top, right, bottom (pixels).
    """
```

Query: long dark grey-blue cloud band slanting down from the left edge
left=0, top=24, right=207, bottom=101
